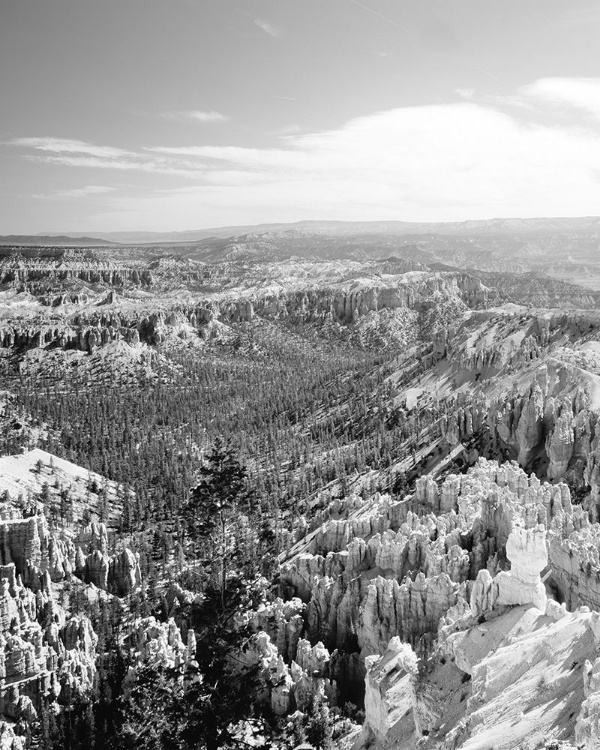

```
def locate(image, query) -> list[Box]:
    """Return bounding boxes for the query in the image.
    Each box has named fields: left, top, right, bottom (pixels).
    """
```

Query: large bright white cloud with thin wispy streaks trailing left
left=9, top=79, right=600, bottom=229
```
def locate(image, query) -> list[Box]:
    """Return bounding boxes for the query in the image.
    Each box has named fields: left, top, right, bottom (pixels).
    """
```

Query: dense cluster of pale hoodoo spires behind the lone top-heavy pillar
left=282, top=460, right=570, bottom=658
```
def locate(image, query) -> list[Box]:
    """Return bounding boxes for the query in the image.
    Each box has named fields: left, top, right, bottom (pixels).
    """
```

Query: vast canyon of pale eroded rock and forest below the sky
left=0, top=226, right=600, bottom=750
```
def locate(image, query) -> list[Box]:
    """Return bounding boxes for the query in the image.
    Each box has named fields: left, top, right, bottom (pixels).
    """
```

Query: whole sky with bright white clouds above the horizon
left=0, top=0, right=600, bottom=234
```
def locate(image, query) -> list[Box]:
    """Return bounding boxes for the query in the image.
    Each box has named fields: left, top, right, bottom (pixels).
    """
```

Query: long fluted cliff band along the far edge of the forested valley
left=0, top=264, right=487, bottom=353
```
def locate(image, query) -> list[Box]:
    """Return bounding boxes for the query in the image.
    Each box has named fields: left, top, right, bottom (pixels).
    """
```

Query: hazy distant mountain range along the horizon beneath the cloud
left=0, top=216, right=600, bottom=246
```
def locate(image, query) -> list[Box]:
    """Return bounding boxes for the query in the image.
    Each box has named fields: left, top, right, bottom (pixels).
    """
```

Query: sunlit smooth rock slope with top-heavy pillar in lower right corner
left=360, top=526, right=600, bottom=750
